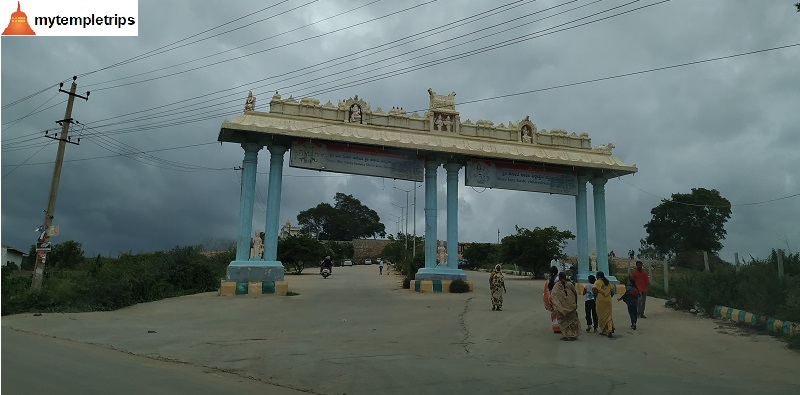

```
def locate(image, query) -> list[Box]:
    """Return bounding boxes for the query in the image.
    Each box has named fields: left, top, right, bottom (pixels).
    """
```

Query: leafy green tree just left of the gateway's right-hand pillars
left=500, top=226, right=575, bottom=273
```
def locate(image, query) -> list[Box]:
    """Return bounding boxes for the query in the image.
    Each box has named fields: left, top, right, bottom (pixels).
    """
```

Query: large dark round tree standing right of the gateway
left=644, top=188, right=731, bottom=255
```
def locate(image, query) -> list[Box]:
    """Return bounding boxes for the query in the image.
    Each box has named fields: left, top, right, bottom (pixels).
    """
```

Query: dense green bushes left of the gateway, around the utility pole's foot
left=2, top=243, right=235, bottom=315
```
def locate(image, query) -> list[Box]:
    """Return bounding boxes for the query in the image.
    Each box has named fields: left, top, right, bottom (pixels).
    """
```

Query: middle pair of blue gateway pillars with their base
left=414, top=160, right=467, bottom=280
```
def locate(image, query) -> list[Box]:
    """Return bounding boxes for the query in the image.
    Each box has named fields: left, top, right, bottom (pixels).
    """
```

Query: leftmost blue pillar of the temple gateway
left=236, top=143, right=261, bottom=261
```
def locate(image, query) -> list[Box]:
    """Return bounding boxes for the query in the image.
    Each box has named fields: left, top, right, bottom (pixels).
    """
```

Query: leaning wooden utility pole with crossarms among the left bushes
left=31, top=77, right=89, bottom=290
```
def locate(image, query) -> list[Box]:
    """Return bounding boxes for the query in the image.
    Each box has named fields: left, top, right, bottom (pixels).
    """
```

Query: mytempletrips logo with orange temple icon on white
left=0, top=0, right=139, bottom=36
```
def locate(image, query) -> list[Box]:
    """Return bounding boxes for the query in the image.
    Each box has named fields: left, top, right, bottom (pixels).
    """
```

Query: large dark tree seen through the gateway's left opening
left=297, top=192, right=386, bottom=240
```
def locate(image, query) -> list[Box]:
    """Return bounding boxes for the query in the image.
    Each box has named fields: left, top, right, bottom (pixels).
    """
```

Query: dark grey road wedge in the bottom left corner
left=2, top=327, right=303, bottom=395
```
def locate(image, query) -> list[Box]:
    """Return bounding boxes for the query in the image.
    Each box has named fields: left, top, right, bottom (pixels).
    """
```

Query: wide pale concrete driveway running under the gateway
left=2, top=265, right=800, bottom=395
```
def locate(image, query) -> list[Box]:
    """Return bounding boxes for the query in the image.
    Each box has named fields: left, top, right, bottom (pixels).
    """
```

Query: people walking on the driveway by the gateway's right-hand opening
left=489, top=261, right=650, bottom=341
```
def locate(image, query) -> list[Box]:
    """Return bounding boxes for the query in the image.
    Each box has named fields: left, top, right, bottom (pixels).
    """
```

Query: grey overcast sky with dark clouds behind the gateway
left=0, top=0, right=800, bottom=261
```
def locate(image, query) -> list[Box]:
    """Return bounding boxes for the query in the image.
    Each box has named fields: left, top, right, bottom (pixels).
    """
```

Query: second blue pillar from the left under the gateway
left=264, top=145, right=286, bottom=263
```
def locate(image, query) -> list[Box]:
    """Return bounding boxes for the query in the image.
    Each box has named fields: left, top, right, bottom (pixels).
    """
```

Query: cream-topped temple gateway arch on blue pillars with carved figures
left=218, top=89, right=637, bottom=294
